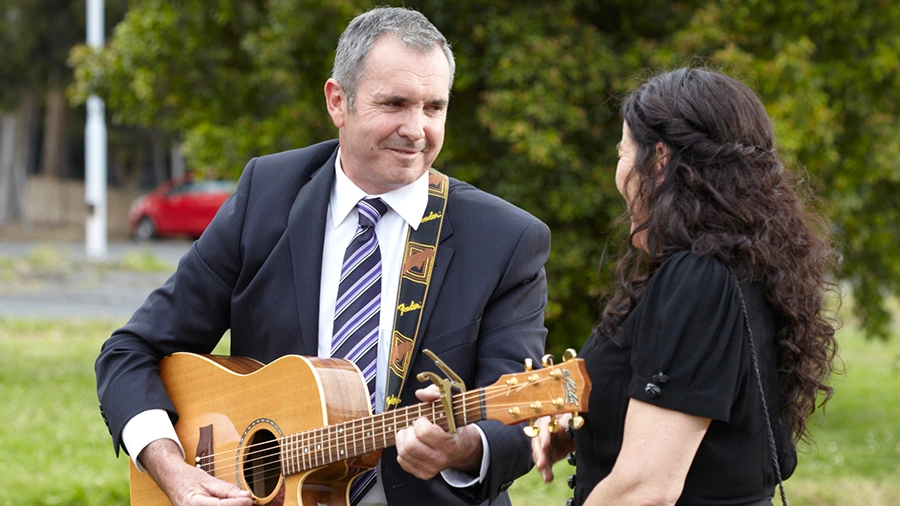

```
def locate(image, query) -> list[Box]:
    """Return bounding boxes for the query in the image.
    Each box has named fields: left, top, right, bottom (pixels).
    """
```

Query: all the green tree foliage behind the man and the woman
left=72, top=0, right=900, bottom=353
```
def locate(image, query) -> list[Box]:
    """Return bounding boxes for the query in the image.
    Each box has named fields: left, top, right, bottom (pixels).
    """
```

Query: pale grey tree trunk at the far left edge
left=0, top=91, right=37, bottom=228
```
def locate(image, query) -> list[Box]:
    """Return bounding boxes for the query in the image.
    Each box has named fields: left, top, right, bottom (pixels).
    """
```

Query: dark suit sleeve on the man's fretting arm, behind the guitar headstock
left=456, top=221, right=550, bottom=502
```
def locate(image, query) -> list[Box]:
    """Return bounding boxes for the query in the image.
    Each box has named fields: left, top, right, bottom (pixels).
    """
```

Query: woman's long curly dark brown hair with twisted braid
left=597, top=68, right=839, bottom=440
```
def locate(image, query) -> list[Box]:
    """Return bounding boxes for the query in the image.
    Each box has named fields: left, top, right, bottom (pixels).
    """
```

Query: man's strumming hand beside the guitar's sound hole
left=138, top=439, right=253, bottom=506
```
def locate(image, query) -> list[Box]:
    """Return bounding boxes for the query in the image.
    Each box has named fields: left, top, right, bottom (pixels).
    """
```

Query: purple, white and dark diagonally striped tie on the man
left=331, top=198, right=388, bottom=504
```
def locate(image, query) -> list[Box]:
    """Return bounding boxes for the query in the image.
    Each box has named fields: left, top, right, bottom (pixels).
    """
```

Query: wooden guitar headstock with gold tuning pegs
left=484, top=350, right=591, bottom=437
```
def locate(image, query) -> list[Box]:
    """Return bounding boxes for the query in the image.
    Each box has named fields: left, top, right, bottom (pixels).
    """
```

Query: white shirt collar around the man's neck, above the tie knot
left=331, top=147, right=428, bottom=230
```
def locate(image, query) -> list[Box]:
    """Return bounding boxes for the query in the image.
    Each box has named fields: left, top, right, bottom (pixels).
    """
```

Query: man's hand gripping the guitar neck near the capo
left=397, top=385, right=484, bottom=480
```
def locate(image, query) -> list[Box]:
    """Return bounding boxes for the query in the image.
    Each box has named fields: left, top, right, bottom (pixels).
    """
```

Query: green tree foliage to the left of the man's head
left=71, top=0, right=355, bottom=178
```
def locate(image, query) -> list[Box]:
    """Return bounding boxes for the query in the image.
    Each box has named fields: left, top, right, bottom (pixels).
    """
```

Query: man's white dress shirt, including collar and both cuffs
left=122, top=148, right=490, bottom=506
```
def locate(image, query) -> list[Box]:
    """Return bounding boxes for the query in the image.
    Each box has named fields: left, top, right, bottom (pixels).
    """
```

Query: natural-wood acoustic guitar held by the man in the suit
left=131, top=353, right=590, bottom=506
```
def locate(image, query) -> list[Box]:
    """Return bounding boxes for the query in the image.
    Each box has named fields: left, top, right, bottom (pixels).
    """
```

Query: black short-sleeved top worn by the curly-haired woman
left=575, top=251, right=797, bottom=505
